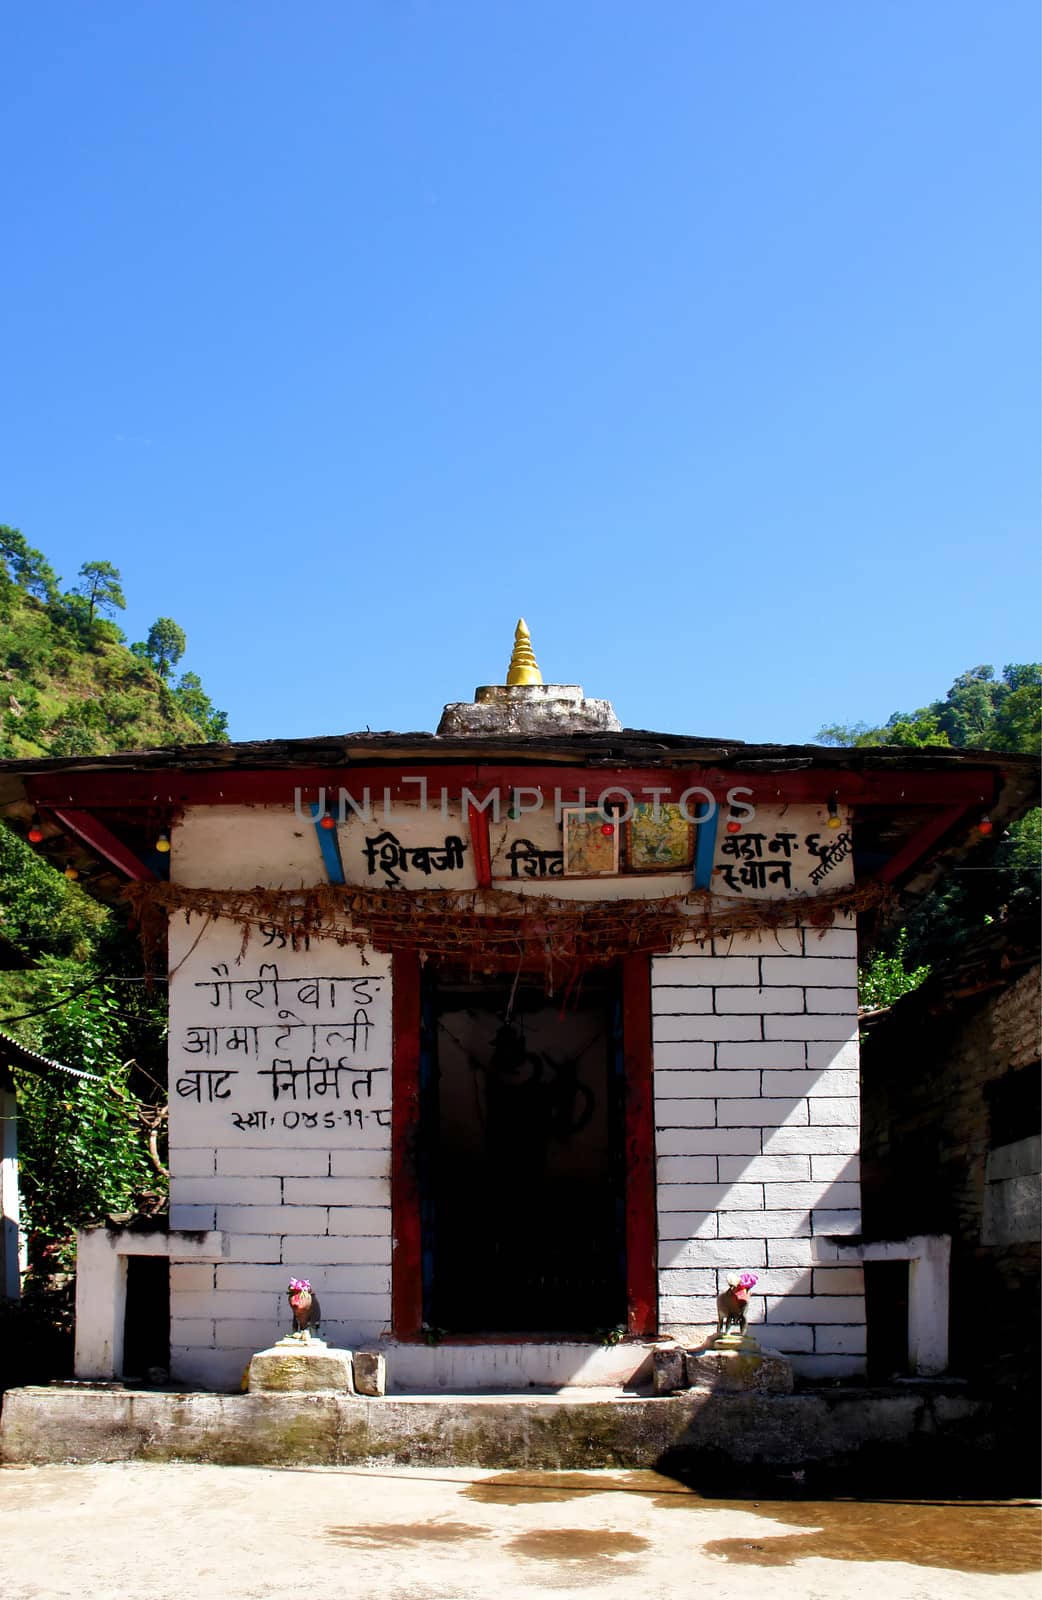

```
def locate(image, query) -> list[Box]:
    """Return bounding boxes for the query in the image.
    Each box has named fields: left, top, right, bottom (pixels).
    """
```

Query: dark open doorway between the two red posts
left=418, top=965, right=626, bottom=1338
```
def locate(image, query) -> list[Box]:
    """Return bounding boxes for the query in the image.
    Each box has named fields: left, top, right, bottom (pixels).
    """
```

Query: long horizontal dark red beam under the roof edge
left=26, top=762, right=999, bottom=818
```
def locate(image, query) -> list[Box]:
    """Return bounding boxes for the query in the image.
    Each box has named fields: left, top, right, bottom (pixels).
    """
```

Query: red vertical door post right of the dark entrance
left=623, top=955, right=658, bottom=1339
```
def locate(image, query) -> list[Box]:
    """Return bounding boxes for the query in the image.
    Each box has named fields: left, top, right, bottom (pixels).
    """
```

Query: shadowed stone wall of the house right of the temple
left=864, top=965, right=1040, bottom=1392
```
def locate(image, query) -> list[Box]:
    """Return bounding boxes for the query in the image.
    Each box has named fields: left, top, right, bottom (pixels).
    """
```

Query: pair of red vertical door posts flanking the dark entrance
left=391, top=950, right=658, bottom=1341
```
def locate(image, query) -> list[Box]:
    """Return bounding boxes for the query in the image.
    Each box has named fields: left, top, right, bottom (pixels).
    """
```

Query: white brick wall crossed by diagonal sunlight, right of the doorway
left=651, top=926, right=864, bottom=1376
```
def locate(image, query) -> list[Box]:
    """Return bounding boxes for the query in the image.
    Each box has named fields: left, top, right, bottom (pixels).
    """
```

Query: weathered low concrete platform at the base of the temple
left=0, top=1384, right=996, bottom=1482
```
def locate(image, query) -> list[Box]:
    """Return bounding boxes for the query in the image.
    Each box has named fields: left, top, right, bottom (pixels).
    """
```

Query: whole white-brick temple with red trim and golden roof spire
left=0, top=632, right=1034, bottom=1389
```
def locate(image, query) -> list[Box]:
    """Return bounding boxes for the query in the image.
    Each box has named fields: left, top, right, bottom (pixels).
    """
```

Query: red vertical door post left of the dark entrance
left=391, top=950, right=423, bottom=1339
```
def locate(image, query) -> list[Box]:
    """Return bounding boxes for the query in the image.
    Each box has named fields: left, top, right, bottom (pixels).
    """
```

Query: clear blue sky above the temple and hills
left=0, top=0, right=1039, bottom=741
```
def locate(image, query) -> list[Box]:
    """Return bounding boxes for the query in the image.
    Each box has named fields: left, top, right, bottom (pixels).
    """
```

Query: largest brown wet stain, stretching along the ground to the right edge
left=463, top=1470, right=1042, bottom=1574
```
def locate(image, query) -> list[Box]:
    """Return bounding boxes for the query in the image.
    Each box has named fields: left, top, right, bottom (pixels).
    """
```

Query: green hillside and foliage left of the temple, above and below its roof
left=0, top=525, right=227, bottom=1381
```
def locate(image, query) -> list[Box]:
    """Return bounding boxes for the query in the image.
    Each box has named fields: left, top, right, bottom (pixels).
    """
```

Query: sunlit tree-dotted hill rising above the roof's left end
left=0, top=525, right=227, bottom=758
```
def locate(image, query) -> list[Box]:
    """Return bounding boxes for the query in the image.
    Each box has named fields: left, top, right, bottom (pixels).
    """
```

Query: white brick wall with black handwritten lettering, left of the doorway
left=170, top=923, right=391, bottom=1387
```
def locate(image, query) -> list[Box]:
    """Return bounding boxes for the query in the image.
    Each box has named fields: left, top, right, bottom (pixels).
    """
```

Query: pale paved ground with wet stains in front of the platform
left=0, top=1462, right=1039, bottom=1600
